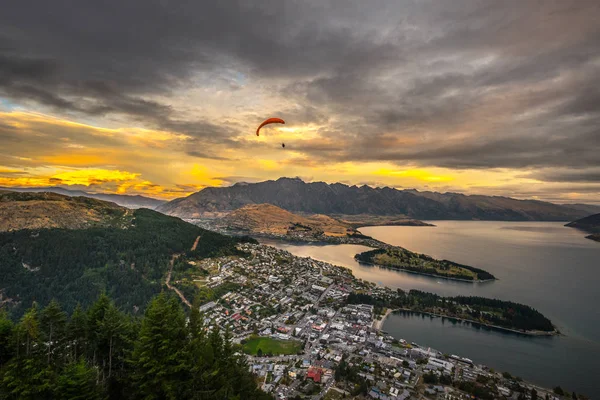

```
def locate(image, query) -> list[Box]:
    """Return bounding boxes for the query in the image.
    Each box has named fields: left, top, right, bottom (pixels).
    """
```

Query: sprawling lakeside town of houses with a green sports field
left=180, top=243, right=560, bottom=400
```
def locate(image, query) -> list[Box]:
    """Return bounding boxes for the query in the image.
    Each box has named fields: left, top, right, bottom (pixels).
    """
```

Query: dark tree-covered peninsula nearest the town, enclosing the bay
left=348, top=289, right=555, bottom=332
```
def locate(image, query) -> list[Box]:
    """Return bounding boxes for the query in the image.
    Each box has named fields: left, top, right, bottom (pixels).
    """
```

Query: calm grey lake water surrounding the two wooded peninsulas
left=264, top=221, right=600, bottom=398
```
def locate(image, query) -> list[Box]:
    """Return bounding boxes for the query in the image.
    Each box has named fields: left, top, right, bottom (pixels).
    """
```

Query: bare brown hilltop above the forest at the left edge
left=0, top=191, right=132, bottom=232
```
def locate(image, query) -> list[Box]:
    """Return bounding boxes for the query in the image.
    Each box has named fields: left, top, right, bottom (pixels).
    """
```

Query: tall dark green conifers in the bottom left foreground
left=0, top=293, right=270, bottom=400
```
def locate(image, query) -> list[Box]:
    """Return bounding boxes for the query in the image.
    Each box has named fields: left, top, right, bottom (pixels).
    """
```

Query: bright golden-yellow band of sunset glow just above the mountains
left=0, top=104, right=592, bottom=200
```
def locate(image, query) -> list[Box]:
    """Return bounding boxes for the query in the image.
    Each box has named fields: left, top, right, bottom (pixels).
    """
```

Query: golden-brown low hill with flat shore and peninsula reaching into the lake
left=190, top=204, right=496, bottom=282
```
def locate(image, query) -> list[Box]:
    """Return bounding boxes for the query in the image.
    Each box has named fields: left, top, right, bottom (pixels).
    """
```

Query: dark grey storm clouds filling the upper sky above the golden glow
left=0, top=0, right=600, bottom=175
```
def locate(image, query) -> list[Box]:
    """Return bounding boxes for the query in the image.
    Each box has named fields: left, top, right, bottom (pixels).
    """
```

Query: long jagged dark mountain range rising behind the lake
left=157, top=178, right=589, bottom=221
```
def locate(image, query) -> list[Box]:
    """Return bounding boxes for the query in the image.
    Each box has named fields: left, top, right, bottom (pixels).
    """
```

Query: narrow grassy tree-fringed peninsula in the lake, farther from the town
left=354, top=246, right=496, bottom=282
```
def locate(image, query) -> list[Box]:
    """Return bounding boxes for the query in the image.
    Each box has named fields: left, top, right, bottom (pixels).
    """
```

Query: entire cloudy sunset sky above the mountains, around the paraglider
left=0, top=0, right=600, bottom=204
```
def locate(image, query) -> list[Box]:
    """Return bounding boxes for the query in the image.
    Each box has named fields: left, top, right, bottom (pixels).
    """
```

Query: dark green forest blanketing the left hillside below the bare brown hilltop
left=0, top=209, right=254, bottom=318
